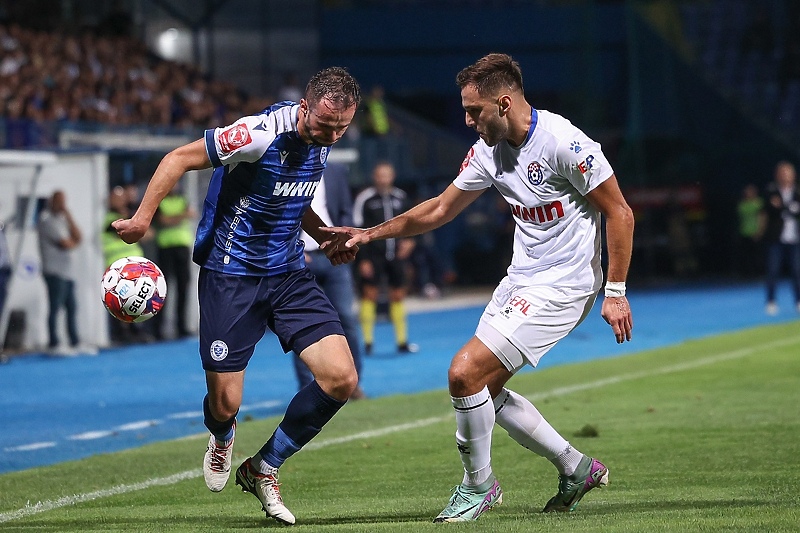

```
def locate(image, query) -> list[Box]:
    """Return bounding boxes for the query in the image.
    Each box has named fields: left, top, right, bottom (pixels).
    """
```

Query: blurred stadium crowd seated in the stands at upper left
left=0, top=25, right=271, bottom=136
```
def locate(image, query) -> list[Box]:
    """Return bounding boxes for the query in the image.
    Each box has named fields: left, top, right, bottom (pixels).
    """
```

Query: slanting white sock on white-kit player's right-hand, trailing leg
left=494, top=389, right=583, bottom=475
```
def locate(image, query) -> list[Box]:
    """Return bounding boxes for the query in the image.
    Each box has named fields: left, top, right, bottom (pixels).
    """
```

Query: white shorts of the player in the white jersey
left=475, top=278, right=598, bottom=373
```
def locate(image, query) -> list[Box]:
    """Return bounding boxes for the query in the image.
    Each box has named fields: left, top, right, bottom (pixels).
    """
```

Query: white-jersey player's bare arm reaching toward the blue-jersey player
left=323, top=184, right=486, bottom=247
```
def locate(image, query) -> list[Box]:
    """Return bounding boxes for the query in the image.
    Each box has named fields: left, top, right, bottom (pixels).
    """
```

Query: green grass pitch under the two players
left=0, top=322, right=800, bottom=533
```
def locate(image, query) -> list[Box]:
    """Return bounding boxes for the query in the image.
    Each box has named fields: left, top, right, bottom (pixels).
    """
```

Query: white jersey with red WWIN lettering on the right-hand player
left=453, top=109, right=614, bottom=291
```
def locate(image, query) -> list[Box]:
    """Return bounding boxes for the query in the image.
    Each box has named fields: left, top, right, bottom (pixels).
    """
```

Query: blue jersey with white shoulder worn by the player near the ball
left=193, top=102, right=328, bottom=276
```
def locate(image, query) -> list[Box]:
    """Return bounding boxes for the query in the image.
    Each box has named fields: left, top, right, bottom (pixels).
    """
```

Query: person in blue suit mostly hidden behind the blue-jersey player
left=293, top=163, right=366, bottom=400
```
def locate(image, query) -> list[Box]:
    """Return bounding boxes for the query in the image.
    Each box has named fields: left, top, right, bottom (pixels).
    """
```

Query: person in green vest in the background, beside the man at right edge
left=736, top=183, right=765, bottom=277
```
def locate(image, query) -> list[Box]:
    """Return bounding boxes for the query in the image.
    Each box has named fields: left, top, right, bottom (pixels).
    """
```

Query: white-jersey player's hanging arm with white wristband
left=587, top=176, right=634, bottom=343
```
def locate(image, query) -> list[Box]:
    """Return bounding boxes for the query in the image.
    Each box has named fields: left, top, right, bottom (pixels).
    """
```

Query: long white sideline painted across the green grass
left=0, top=336, right=800, bottom=524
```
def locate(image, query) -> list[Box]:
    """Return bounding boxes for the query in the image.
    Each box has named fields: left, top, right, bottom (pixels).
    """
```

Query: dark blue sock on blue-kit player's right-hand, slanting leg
left=259, top=381, right=345, bottom=468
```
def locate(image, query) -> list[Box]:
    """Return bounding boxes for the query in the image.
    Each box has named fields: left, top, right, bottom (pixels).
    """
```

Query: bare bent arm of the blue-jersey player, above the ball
left=111, top=139, right=211, bottom=244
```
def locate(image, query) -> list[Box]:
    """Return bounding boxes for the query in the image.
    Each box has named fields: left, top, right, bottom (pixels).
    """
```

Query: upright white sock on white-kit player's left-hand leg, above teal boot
left=450, top=387, right=494, bottom=486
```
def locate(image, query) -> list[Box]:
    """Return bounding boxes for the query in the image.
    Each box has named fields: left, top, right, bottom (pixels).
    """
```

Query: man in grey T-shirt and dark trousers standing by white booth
left=38, top=191, right=88, bottom=356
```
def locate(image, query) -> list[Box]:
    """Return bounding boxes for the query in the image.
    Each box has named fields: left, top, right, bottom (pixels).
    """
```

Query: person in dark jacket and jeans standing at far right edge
left=764, top=161, right=800, bottom=315
